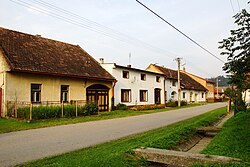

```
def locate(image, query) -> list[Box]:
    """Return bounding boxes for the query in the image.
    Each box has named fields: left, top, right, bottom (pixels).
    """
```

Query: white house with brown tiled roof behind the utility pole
left=146, top=64, right=207, bottom=102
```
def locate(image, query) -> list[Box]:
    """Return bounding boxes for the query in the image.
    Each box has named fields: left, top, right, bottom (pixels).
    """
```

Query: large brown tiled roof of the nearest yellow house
left=0, top=27, right=114, bottom=80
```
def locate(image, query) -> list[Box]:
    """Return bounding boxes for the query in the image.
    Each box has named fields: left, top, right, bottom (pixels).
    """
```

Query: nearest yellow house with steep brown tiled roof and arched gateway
left=0, top=28, right=115, bottom=116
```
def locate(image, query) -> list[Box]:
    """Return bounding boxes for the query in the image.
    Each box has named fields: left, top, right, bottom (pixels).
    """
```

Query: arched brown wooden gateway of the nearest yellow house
left=87, top=84, right=109, bottom=111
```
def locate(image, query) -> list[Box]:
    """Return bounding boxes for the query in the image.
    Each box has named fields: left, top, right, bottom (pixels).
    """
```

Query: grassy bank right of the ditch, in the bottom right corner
left=199, top=109, right=250, bottom=166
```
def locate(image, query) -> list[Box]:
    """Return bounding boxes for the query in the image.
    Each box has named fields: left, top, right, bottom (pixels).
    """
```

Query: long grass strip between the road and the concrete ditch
left=16, top=107, right=226, bottom=167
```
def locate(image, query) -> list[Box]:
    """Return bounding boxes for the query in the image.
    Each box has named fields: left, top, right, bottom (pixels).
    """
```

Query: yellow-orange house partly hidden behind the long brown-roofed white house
left=181, top=70, right=215, bottom=102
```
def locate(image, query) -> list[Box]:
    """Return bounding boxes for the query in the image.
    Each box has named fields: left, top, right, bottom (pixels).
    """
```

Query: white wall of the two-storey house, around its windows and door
left=101, top=64, right=165, bottom=106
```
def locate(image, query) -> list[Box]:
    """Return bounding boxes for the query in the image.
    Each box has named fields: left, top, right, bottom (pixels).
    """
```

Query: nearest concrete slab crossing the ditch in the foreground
left=134, top=148, right=241, bottom=166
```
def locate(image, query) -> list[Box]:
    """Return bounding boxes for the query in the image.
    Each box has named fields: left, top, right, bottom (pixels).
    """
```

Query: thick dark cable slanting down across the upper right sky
left=136, top=0, right=225, bottom=63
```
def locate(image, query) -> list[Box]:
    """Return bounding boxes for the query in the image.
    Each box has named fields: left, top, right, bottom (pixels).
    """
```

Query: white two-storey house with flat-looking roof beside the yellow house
left=101, top=60, right=165, bottom=106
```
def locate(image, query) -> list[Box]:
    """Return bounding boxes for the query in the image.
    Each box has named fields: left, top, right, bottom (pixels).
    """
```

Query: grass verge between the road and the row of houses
left=0, top=104, right=202, bottom=133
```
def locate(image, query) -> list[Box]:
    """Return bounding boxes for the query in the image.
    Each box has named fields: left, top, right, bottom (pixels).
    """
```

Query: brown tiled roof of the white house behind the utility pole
left=151, top=65, right=207, bottom=91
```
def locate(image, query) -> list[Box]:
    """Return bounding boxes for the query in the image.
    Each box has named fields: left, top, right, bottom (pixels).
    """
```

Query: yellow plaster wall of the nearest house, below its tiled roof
left=0, top=50, right=112, bottom=116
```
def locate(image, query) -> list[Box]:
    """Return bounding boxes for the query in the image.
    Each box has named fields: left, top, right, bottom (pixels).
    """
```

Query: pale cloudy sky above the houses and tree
left=0, top=0, right=250, bottom=78
